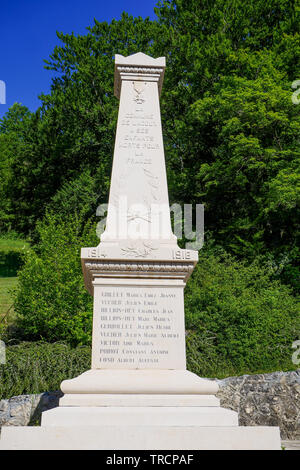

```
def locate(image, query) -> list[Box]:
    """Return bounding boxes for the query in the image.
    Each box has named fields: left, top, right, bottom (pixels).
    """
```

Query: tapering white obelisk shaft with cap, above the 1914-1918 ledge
left=101, top=54, right=177, bottom=248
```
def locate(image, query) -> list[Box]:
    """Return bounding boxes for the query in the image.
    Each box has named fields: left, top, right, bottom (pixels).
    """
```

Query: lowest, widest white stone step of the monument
left=0, top=426, right=281, bottom=450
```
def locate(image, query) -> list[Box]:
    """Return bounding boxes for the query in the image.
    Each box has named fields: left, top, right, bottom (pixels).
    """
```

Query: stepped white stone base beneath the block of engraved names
left=0, top=370, right=281, bottom=450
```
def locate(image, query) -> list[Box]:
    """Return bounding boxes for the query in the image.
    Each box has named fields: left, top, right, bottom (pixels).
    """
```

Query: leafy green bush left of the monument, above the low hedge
left=14, top=213, right=98, bottom=345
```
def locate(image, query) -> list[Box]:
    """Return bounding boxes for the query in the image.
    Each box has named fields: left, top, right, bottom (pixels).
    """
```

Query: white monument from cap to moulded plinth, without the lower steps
left=61, top=53, right=217, bottom=400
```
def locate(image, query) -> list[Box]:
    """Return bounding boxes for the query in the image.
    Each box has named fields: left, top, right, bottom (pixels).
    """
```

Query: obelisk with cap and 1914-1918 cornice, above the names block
left=81, top=52, right=198, bottom=293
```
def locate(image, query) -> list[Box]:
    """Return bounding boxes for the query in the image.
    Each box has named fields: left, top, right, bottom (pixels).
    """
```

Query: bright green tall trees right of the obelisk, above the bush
left=153, top=0, right=300, bottom=265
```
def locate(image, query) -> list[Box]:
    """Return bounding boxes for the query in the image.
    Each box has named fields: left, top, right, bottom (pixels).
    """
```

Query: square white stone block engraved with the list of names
left=92, top=286, right=185, bottom=369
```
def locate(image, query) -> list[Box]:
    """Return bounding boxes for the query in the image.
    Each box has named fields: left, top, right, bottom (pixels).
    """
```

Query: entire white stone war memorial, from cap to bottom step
left=0, top=52, right=280, bottom=450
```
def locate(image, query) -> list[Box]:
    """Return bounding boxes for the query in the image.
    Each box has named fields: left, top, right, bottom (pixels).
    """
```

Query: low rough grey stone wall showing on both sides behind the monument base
left=0, top=369, right=300, bottom=440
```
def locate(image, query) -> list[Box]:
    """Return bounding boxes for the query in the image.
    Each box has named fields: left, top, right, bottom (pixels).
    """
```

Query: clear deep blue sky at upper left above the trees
left=0, top=0, right=157, bottom=118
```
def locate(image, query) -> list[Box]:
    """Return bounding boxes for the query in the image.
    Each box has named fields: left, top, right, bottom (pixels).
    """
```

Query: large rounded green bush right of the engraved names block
left=185, top=251, right=300, bottom=377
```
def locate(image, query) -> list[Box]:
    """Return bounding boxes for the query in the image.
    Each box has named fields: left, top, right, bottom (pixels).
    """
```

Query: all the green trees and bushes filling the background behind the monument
left=0, top=0, right=300, bottom=396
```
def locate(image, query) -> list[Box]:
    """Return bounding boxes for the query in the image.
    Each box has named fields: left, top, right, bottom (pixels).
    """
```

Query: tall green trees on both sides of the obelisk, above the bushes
left=0, top=0, right=300, bottom=281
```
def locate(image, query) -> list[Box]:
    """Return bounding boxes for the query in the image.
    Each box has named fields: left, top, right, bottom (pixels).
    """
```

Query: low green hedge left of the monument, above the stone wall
left=0, top=342, right=91, bottom=400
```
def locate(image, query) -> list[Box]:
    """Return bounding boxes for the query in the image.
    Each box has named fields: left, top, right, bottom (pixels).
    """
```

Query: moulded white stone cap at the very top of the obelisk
left=114, top=52, right=166, bottom=98
